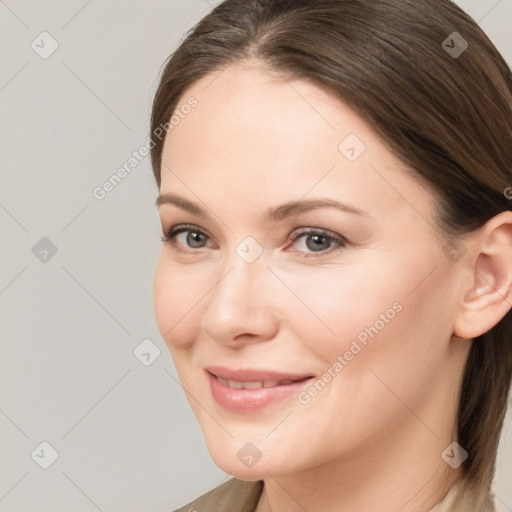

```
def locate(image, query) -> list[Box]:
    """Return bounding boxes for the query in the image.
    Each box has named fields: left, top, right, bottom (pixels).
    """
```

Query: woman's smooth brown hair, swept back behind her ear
left=151, top=0, right=512, bottom=492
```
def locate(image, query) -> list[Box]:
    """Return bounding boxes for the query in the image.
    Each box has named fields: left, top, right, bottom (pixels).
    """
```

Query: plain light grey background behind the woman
left=0, top=0, right=512, bottom=512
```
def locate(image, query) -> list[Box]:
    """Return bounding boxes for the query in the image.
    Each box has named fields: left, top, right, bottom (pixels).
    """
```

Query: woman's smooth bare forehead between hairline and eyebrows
left=161, top=64, right=434, bottom=224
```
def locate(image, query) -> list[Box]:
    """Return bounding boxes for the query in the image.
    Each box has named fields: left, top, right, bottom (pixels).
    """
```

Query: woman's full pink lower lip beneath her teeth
left=206, top=372, right=313, bottom=413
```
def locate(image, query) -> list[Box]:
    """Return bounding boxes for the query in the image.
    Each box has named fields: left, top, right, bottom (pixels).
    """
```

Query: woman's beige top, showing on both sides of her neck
left=174, top=478, right=496, bottom=512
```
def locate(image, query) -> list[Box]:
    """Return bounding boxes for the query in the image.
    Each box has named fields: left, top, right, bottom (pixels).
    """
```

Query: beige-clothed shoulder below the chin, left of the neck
left=174, top=478, right=263, bottom=512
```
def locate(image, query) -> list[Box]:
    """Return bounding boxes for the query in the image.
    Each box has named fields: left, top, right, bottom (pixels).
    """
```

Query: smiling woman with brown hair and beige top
left=151, top=0, right=512, bottom=512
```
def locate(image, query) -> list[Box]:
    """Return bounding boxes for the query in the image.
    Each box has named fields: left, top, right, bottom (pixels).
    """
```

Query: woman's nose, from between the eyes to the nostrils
left=201, top=254, right=279, bottom=347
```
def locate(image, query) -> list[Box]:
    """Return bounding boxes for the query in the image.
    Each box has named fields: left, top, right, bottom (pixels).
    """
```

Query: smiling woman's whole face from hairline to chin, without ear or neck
left=154, top=64, right=465, bottom=480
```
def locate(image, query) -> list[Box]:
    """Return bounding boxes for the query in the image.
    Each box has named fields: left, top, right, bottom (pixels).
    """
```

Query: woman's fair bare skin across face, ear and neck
left=154, top=62, right=512, bottom=512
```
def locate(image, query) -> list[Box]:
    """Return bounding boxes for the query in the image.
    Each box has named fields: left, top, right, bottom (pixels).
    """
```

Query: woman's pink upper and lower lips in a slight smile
left=205, top=367, right=313, bottom=414
